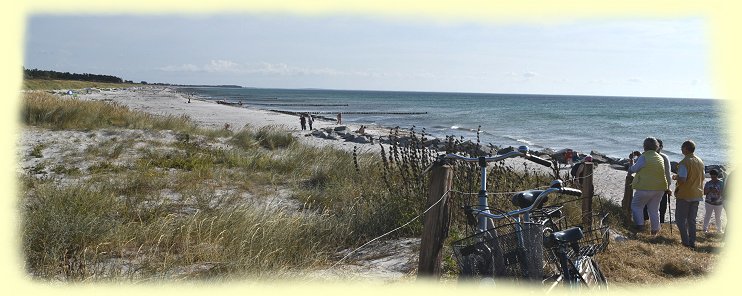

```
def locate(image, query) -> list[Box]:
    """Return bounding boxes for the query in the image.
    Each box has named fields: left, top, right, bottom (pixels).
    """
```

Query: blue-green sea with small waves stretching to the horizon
left=180, top=87, right=732, bottom=166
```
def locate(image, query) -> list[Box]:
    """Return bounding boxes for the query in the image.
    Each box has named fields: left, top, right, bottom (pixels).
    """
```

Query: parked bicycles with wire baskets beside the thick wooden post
left=445, top=146, right=607, bottom=290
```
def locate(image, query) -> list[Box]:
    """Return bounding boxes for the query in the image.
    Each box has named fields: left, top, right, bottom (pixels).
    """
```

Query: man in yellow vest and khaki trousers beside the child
left=673, top=140, right=704, bottom=248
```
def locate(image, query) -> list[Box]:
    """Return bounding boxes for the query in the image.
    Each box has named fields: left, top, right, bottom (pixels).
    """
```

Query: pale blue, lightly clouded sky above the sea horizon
left=24, top=13, right=714, bottom=98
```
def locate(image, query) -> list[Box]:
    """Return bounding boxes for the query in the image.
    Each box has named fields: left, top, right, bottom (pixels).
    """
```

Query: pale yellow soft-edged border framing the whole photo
left=0, top=0, right=742, bottom=295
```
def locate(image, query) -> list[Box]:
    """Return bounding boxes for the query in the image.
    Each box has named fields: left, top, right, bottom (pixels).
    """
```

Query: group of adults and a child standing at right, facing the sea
left=629, top=137, right=724, bottom=248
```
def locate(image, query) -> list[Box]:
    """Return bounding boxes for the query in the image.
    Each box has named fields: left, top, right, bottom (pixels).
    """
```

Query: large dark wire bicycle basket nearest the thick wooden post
left=453, top=222, right=544, bottom=281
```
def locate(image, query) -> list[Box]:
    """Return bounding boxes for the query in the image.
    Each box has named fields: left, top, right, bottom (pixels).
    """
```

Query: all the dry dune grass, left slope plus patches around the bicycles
left=19, top=92, right=723, bottom=285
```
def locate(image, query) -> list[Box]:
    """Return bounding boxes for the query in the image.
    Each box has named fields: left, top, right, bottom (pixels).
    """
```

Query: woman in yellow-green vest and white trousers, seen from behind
left=629, top=137, right=669, bottom=235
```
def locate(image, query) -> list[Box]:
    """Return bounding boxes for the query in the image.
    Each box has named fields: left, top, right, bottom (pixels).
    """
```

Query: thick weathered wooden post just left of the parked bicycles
left=417, top=163, right=453, bottom=279
